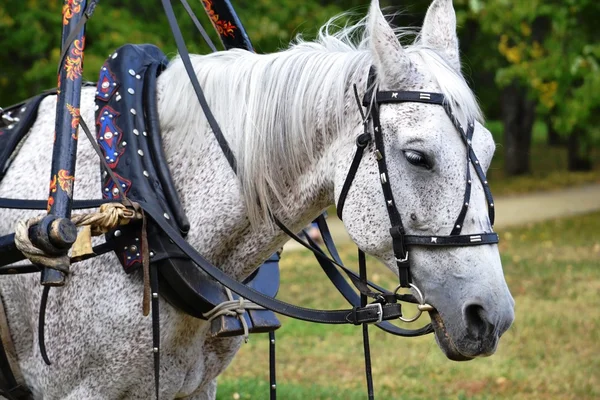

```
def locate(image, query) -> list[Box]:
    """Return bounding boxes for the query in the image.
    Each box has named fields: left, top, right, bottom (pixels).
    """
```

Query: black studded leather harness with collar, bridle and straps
left=0, top=26, right=498, bottom=399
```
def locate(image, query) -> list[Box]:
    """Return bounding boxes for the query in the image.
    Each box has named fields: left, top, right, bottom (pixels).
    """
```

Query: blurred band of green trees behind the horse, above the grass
left=0, top=0, right=600, bottom=181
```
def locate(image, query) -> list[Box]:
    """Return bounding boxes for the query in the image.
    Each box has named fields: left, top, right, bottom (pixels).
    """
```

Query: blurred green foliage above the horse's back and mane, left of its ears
left=0, top=0, right=346, bottom=106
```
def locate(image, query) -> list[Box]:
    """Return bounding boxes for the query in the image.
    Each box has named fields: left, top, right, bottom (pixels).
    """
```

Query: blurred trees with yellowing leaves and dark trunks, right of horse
left=469, top=0, right=600, bottom=174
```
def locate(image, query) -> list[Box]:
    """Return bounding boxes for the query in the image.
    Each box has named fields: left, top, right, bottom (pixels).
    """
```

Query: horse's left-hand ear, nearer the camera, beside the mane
left=368, top=0, right=410, bottom=84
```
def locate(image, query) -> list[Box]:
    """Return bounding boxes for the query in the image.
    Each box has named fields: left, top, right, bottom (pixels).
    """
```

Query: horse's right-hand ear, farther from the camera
left=421, top=0, right=460, bottom=72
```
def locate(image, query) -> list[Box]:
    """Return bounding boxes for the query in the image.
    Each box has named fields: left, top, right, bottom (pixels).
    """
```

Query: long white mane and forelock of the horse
left=159, top=14, right=482, bottom=225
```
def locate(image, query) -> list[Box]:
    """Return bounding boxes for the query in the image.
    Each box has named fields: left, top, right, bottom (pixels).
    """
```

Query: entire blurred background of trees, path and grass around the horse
left=0, top=0, right=600, bottom=399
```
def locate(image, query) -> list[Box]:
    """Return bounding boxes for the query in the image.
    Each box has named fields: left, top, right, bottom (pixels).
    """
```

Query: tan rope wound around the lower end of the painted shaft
left=15, top=203, right=142, bottom=274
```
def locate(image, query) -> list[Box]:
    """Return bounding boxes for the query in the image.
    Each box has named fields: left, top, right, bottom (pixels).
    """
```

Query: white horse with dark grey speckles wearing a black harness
left=0, top=0, right=514, bottom=400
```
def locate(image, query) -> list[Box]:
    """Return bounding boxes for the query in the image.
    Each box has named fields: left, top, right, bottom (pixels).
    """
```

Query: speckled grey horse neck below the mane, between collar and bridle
left=158, top=59, right=364, bottom=278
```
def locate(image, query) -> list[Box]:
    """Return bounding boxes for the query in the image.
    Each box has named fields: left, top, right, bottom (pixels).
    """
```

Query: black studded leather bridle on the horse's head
left=337, top=67, right=498, bottom=296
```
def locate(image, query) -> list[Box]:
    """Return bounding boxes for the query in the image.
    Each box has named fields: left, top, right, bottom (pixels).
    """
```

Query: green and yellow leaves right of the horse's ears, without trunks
left=467, top=0, right=600, bottom=148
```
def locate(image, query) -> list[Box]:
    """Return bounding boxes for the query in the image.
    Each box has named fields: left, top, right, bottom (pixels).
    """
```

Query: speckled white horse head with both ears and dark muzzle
left=335, top=0, right=514, bottom=360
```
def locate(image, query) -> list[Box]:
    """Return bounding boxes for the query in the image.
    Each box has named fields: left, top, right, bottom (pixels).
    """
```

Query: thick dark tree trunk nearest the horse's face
left=502, top=83, right=535, bottom=176
